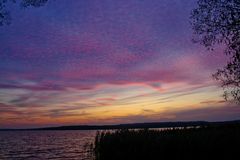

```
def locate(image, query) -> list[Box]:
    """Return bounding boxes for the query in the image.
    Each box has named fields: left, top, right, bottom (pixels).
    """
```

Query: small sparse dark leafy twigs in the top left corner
left=0, top=0, right=48, bottom=26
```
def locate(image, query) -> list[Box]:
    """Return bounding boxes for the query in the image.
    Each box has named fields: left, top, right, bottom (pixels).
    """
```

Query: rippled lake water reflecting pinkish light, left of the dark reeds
left=0, top=131, right=96, bottom=160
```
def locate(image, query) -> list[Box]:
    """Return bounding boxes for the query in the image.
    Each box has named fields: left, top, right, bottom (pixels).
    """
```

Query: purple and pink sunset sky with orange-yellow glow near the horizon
left=0, top=0, right=240, bottom=128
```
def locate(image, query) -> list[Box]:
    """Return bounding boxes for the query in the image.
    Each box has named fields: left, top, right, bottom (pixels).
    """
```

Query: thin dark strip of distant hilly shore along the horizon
left=0, top=120, right=240, bottom=131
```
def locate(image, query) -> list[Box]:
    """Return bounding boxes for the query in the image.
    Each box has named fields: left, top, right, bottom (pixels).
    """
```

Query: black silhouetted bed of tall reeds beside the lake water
left=92, top=123, right=240, bottom=160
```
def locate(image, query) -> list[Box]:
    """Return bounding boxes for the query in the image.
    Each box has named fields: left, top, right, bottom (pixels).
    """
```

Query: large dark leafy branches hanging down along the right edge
left=191, top=0, right=240, bottom=103
